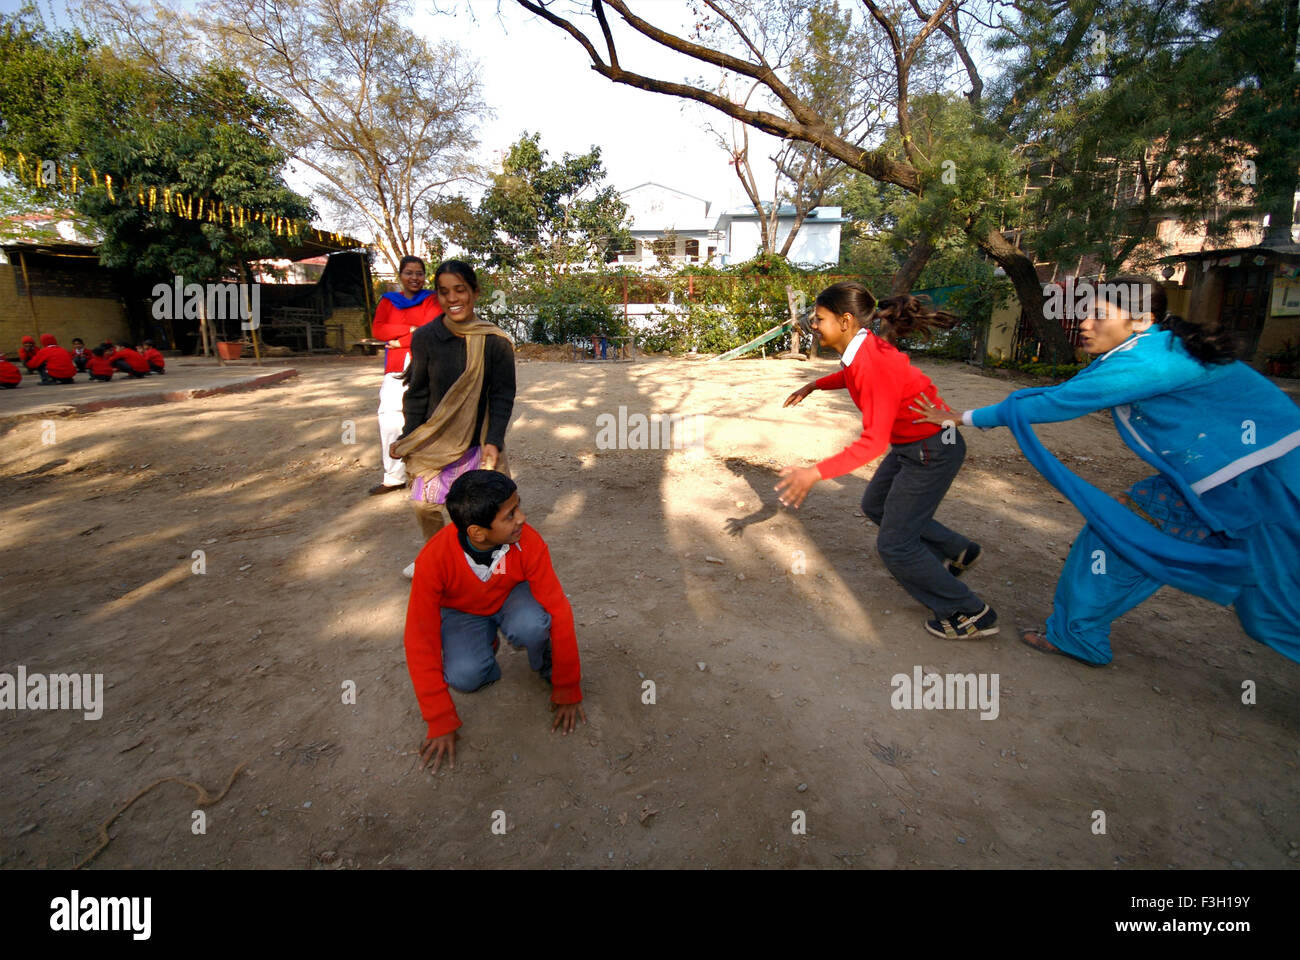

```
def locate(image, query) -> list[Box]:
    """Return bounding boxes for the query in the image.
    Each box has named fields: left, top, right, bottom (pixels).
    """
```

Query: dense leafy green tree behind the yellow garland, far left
left=0, top=8, right=313, bottom=335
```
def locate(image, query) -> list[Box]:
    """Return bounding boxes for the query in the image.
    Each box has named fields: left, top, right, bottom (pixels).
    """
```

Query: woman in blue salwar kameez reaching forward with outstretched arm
left=914, top=277, right=1300, bottom=666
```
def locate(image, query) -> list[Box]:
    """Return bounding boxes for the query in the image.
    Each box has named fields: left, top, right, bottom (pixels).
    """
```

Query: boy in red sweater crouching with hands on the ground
left=404, top=470, right=586, bottom=773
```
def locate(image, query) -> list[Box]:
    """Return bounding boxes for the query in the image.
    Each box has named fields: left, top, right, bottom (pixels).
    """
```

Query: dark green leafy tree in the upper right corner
left=991, top=0, right=1300, bottom=273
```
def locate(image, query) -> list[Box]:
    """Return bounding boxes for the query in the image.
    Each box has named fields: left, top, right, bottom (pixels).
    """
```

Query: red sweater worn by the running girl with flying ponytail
left=816, top=330, right=946, bottom=480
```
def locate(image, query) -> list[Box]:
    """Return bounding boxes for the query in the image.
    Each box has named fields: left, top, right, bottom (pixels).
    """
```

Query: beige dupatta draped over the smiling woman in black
left=393, top=315, right=515, bottom=483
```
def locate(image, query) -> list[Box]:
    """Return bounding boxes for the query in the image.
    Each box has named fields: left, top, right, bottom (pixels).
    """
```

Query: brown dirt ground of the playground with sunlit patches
left=0, top=359, right=1300, bottom=869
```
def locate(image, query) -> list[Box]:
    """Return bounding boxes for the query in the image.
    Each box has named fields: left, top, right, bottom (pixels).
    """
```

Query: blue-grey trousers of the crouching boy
left=442, top=581, right=551, bottom=693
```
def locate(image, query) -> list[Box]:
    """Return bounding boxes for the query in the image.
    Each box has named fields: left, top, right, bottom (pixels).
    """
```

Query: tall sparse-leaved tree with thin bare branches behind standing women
left=95, top=0, right=488, bottom=273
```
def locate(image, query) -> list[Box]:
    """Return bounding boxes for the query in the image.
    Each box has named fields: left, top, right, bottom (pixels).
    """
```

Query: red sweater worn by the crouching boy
left=404, top=523, right=582, bottom=739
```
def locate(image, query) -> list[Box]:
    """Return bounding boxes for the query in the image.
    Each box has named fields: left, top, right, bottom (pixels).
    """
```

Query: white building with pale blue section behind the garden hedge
left=614, top=183, right=848, bottom=267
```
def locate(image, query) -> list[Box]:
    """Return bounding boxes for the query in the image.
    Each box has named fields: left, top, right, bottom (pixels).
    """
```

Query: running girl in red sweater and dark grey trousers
left=776, top=282, right=997, bottom=640
